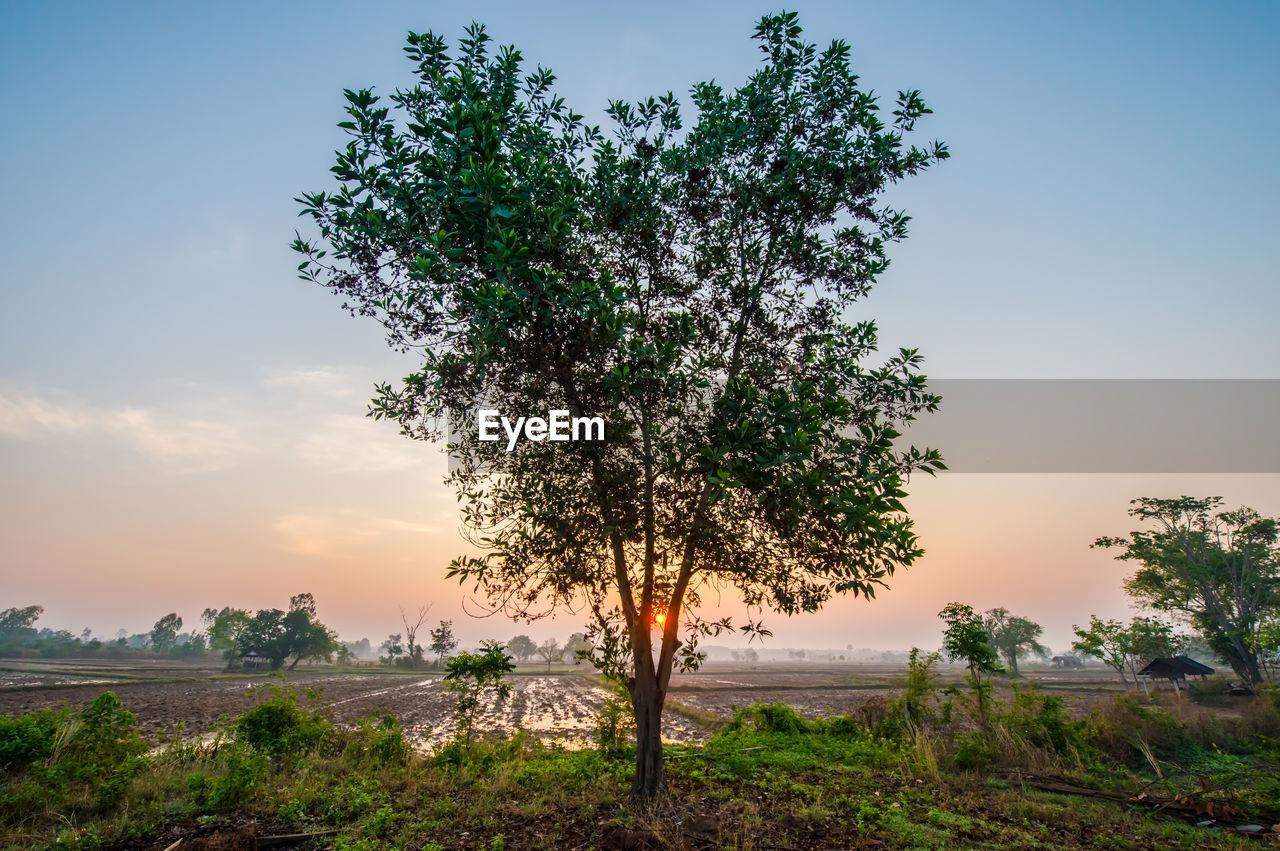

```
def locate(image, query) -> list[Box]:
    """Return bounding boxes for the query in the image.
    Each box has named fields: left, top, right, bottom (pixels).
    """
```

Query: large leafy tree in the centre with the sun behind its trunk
left=293, top=13, right=947, bottom=797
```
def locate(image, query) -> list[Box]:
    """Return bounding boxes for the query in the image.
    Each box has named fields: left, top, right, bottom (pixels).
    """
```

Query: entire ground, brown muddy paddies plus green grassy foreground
left=0, top=660, right=1280, bottom=851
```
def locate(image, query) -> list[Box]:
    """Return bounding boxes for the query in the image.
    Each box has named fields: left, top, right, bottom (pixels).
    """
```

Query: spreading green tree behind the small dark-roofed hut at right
left=1093, top=497, right=1280, bottom=683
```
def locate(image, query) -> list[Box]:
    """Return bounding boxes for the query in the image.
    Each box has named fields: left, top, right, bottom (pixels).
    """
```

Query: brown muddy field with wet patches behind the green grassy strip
left=0, top=662, right=1141, bottom=746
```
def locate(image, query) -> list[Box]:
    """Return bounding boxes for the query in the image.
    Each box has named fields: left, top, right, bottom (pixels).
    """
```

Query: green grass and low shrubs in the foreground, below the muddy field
left=0, top=687, right=1280, bottom=851
